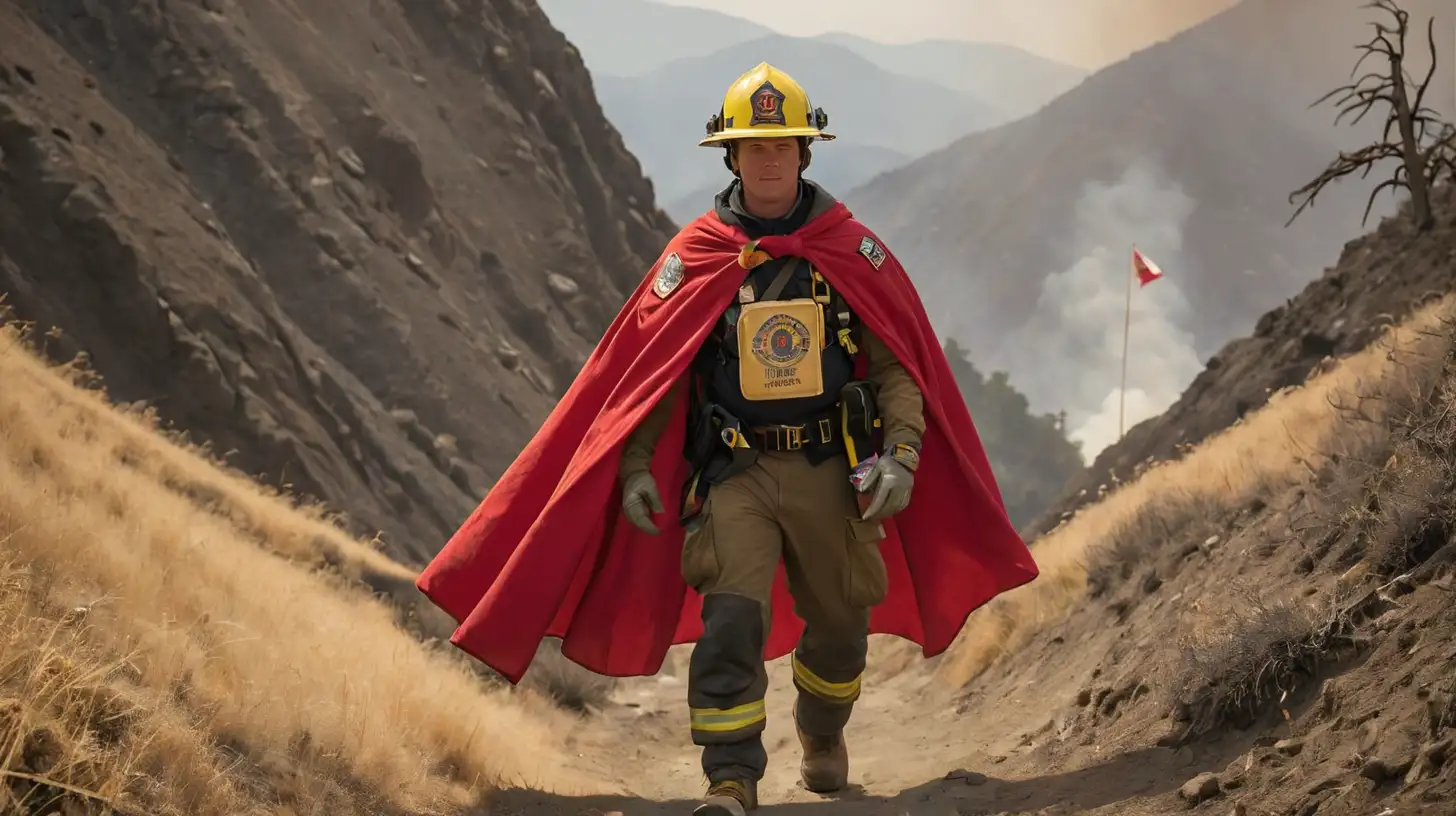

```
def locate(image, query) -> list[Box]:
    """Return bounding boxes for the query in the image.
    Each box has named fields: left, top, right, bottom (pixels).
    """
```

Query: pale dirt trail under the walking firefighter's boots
left=494, top=649, right=1184, bottom=816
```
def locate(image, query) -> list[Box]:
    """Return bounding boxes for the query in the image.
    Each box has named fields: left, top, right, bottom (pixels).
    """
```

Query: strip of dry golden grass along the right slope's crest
left=933, top=296, right=1456, bottom=689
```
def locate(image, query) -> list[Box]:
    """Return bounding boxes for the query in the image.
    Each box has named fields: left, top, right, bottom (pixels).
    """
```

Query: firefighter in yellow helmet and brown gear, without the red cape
left=619, top=63, right=925, bottom=816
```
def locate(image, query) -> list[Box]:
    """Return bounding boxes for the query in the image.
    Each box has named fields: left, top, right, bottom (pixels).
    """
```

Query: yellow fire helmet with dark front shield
left=697, top=63, right=834, bottom=147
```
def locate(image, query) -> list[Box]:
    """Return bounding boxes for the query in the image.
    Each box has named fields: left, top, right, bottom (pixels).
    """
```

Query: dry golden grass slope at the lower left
left=0, top=328, right=602, bottom=816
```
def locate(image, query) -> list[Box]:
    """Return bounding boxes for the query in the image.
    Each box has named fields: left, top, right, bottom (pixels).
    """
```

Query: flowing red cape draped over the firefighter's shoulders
left=416, top=203, right=1037, bottom=683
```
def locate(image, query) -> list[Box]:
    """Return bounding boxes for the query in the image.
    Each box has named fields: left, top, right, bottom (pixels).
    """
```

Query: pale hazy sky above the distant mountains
left=661, top=0, right=1236, bottom=68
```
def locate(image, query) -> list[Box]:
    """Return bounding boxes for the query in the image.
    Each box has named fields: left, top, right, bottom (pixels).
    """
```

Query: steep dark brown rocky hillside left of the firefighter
left=0, top=0, right=673, bottom=562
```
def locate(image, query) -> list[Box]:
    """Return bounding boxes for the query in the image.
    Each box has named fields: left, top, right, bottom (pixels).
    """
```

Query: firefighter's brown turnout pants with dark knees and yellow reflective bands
left=683, top=450, right=888, bottom=781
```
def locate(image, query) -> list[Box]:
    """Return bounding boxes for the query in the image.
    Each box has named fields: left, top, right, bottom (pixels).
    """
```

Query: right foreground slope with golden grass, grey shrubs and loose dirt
left=898, top=289, right=1456, bottom=816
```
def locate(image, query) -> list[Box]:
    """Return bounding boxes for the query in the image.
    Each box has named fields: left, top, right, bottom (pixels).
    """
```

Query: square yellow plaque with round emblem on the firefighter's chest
left=738, top=297, right=824, bottom=401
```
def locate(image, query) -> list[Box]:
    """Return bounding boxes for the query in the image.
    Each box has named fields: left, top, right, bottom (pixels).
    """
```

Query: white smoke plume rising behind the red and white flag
left=992, top=159, right=1203, bottom=460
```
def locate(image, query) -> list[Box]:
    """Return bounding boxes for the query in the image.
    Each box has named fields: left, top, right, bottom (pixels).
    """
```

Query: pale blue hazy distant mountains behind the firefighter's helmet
left=542, top=0, right=1085, bottom=221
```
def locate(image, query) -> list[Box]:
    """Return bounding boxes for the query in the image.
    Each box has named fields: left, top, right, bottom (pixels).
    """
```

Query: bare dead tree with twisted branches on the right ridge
left=1284, top=0, right=1456, bottom=230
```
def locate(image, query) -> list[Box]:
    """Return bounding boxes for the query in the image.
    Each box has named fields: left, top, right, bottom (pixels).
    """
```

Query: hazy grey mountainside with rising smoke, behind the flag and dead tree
left=846, top=0, right=1456, bottom=453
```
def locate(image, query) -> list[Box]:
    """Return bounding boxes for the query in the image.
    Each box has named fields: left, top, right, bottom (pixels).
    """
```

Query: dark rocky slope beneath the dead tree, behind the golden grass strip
left=1029, top=184, right=1456, bottom=535
